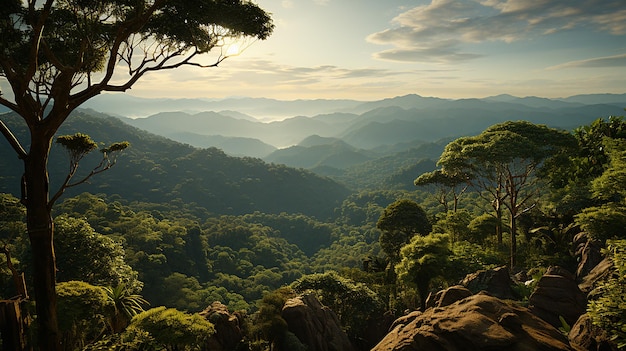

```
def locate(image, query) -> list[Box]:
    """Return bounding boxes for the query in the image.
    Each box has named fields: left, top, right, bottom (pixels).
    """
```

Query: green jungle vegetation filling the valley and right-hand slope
left=0, top=117, right=626, bottom=350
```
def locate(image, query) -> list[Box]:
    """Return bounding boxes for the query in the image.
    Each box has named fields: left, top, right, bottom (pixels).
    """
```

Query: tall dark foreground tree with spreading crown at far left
left=0, top=0, right=273, bottom=350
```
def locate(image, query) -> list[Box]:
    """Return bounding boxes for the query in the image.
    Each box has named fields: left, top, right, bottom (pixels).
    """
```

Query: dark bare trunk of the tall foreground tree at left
left=22, top=132, right=60, bottom=351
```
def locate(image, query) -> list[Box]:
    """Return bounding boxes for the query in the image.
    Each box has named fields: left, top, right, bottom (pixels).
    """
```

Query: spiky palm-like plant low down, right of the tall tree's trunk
left=104, top=284, right=150, bottom=333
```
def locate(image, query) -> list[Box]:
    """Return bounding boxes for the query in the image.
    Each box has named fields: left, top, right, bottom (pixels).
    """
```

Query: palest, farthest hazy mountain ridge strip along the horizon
left=82, top=93, right=626, bottom=122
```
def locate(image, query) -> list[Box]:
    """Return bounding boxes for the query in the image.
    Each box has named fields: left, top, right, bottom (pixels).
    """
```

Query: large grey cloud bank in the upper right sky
left=367, top=0, right=626, bottom=62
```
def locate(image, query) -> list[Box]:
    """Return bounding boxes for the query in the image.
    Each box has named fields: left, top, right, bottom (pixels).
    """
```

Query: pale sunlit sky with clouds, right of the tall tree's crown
left=122, top=0, right=626, bottom=100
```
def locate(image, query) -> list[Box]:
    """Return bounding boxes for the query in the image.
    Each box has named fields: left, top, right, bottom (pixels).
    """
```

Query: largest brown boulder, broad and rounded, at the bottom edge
left=372, top=293, right=572, bottom=351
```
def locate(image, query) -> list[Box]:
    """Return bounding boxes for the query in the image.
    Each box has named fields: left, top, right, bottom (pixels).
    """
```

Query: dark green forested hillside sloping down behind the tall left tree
left=0, top=112, right=349, bottom=219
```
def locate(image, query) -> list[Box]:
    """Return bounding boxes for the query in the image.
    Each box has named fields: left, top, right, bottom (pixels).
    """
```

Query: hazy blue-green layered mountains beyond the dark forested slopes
left=86, top=94, right=626, bottom=174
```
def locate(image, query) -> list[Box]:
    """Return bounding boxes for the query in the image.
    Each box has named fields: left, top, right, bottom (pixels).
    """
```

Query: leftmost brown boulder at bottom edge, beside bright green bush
left=200, top=301, right=244, bottom=351
